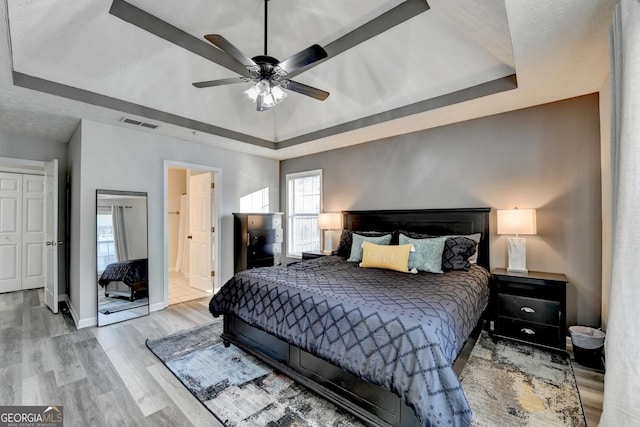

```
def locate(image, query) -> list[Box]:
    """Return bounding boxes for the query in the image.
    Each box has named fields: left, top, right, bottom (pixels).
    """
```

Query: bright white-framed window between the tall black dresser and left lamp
left=287, top=169, right=322, bottom=258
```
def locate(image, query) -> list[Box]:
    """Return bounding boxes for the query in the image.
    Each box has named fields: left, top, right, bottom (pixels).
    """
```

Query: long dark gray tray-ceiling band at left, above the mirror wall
left=13, top=71, right=276, bottom=149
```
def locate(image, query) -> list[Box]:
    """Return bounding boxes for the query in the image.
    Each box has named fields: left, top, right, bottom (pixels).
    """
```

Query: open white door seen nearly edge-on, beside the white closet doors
left=44, top=159, right=57, bottom=313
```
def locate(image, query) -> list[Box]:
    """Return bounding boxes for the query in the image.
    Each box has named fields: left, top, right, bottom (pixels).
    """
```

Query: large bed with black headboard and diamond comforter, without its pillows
left=210, top=208, right=490, bottom=427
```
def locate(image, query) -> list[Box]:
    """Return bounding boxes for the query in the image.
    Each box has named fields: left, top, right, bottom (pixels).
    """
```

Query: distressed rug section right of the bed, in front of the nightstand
left=460, top=331, right=587, bottom=427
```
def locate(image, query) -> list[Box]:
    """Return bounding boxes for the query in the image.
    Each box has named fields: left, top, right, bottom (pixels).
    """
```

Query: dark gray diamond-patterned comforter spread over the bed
left=209, top=256, right=489, bottom=426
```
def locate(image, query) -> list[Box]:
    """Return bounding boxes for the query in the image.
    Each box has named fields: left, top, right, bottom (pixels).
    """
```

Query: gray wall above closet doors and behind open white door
left=0, top=132, right=68, bottom=295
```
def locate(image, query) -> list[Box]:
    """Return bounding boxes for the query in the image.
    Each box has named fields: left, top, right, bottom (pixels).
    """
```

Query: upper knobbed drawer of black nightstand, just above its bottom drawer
left=498, top=294, right=560, bottom=326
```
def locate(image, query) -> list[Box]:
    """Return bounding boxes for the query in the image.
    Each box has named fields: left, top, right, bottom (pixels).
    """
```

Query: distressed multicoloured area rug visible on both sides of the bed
left=147, top=320, right=586, bottom=427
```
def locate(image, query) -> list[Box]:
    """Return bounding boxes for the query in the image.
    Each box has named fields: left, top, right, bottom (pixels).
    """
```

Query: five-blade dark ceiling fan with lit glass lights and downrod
left=193, top=0, right=329, bottom=111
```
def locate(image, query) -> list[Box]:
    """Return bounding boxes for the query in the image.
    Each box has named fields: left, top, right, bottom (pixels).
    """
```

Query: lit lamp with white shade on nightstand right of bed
left=498, top=208, right=536, bottom=274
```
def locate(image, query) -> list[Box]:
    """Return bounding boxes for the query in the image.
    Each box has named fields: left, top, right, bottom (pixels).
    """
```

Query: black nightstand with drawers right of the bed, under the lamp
left=492, top=268, right=567, bottom=351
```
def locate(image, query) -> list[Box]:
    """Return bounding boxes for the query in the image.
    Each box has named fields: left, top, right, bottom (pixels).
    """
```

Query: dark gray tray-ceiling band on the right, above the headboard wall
left=276, top=74, right=518, bottom=150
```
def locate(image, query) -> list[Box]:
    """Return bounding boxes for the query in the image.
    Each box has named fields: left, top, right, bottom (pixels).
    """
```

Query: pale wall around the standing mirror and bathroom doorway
left=70, top=121, right=279, bottom=327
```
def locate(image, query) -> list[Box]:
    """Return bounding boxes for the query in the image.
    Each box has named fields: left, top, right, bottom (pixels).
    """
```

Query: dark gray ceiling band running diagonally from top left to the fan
left=109, top=0, right=251, bottom=77
